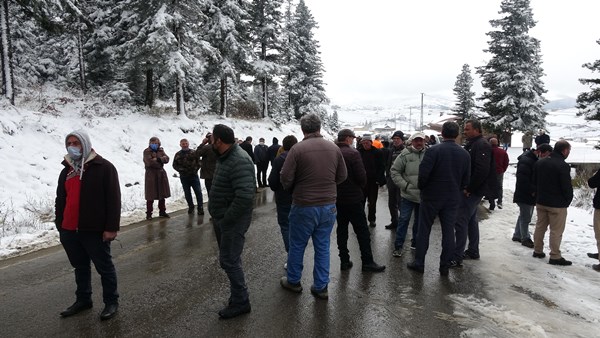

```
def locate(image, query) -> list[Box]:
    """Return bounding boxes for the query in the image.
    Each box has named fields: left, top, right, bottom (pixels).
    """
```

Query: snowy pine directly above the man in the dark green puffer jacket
left=205, top=0, right=252, bottom=117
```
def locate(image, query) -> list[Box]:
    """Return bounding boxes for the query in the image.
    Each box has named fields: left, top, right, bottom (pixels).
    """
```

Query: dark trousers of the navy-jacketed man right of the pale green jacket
left=415, top=197, right=459, bottom=267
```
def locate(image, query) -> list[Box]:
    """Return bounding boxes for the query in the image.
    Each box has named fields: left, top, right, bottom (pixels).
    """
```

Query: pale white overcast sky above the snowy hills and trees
left=305, top=0, right=600, bottom=105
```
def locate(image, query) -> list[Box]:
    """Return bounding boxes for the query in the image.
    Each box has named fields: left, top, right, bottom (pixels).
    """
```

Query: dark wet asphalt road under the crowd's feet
left=0, top=190, right=486, bottom=337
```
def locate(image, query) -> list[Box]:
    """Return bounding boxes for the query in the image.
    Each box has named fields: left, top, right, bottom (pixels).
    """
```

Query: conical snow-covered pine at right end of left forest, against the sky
left=284, top=0, right=328, bottom=119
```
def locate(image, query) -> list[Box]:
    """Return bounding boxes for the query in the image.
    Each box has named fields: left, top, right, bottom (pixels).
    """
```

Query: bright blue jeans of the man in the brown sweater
left=287, top=204, right=336, bottom=290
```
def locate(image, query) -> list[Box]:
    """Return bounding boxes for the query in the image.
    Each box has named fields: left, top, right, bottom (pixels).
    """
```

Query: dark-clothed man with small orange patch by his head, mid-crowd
left=359, top=134, right=385, bottom=228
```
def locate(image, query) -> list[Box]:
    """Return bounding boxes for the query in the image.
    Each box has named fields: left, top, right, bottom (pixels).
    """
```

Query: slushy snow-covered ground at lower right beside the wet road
left=451, top=162, right=600, bottom=337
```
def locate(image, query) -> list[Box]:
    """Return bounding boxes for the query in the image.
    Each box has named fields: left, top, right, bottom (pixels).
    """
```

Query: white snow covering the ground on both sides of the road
left=0, top=97, right=600, bottom=337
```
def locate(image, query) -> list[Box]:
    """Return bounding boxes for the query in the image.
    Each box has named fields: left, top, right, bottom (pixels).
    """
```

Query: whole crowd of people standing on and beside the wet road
left=55, top=114, right=600, bottom=320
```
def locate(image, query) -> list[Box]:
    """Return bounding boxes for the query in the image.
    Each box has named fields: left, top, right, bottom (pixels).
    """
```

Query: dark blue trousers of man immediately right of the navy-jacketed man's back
left=454, top=194, right=482, bottom=262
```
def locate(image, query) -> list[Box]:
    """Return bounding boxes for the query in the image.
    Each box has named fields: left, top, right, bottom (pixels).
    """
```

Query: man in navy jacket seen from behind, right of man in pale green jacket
left=407, top=122, right=471, bottom=276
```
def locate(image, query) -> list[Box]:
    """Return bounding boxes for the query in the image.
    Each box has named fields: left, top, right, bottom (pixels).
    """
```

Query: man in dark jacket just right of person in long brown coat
left=173, top=139, right=204, bottom=215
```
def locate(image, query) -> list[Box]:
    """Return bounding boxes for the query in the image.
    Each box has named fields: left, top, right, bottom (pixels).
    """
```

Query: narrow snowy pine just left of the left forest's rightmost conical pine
left=250, top=0, right=282, bottom=118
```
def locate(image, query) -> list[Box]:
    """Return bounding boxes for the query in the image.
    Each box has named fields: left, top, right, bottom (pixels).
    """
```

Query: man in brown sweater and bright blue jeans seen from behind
left=280, top=114, right=347, bottom=299
